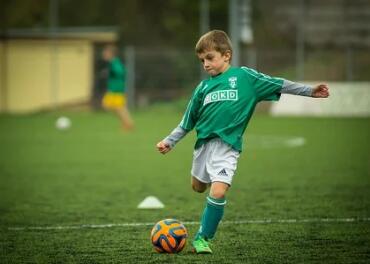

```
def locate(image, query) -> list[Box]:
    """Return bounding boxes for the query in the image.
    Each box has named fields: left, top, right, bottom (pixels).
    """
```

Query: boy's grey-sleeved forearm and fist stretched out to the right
left=281, top=80, right=329, bottom=98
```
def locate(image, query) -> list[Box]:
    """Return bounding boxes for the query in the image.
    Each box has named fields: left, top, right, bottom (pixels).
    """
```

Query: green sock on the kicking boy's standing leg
left=195, top=196, right=226, bottom=239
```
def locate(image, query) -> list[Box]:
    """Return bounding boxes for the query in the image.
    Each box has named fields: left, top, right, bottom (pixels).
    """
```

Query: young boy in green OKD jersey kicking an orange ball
left=157, top=30, right=329, bottom=254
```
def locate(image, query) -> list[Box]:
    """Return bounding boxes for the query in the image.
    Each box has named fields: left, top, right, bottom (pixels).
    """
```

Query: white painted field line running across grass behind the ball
left=8, top=217, right=370, bottom=231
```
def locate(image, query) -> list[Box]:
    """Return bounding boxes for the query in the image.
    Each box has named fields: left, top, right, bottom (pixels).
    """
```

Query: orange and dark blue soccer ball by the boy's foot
left=151, top=219, right=188, bottom=253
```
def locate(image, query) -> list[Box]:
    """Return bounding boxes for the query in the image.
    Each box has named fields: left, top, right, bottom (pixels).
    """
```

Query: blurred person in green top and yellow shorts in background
left=102, top=45, right=134, bottom=130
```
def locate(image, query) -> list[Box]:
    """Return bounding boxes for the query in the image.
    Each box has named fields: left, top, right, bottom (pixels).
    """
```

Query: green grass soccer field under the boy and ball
left=0, top=105, right=370, bottom=263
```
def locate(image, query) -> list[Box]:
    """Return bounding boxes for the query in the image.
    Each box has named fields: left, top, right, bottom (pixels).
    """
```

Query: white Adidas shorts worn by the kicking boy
left=191, top=138, right=240, bottom=185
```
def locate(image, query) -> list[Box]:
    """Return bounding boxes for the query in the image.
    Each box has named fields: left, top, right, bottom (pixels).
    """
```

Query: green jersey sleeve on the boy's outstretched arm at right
left=242, top=67, right=284, bottom=101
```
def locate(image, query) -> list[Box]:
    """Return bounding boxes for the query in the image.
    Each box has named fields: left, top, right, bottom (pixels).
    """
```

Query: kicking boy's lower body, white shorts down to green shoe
left=192, top=139, right=237, bottom=253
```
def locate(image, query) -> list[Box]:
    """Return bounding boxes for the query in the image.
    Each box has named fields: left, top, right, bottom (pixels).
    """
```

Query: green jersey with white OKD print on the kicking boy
left=180, top=67, right=284, bottom=151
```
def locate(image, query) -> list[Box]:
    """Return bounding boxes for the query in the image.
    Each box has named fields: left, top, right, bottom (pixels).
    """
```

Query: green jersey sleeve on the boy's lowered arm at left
left=180, top=83, right=202, bottom=131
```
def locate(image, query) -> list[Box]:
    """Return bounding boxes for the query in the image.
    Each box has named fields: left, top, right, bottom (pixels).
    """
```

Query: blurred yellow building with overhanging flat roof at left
left=0, top=28, right=117, bottom=113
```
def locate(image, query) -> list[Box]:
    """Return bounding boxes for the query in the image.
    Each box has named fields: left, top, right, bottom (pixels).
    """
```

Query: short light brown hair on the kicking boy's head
left=195, top=30, right=233, bottom=60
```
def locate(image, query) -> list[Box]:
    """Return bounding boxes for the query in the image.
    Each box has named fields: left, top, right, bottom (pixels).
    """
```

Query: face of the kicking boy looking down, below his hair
left=198, top=50, right=231, bottom=76
